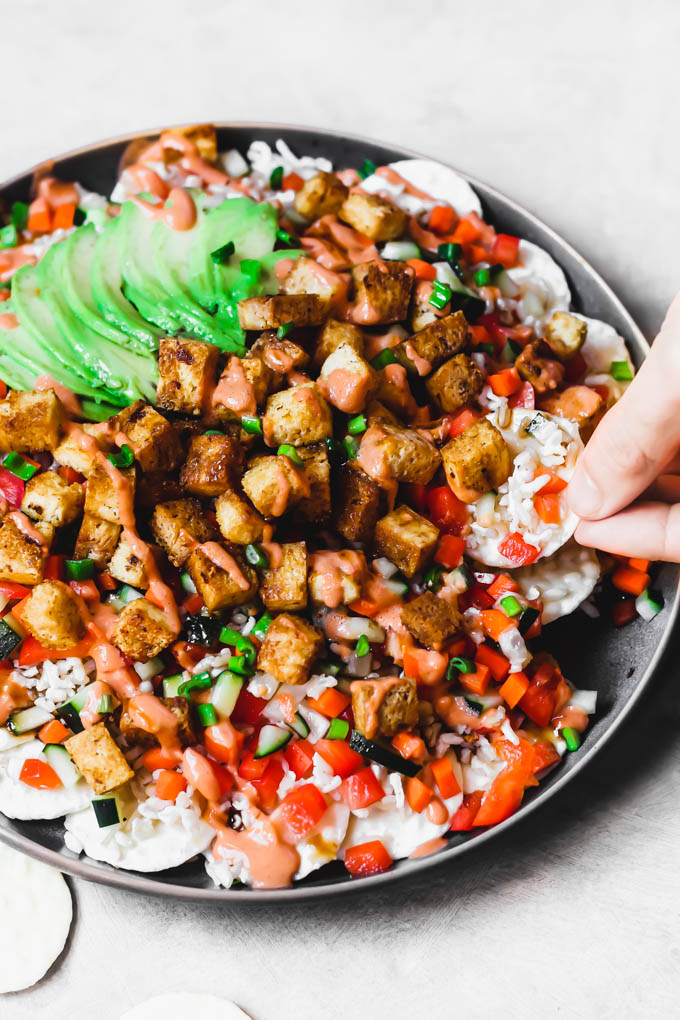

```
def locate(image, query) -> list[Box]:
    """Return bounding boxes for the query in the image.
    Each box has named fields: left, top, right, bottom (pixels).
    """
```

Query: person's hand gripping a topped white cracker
left=567, top=295, right=680, bottom=562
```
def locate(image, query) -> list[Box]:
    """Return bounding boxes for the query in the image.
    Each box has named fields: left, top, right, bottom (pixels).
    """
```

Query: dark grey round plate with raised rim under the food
left=0, top=124, right=680, bottom=903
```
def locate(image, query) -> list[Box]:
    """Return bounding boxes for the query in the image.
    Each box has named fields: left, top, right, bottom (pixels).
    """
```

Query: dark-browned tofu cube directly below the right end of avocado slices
left=156, top=337, right=219, bottom=415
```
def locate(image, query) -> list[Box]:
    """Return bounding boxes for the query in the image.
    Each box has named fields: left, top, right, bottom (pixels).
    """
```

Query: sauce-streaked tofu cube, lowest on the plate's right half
left=351, top=676, right=418, bottom=741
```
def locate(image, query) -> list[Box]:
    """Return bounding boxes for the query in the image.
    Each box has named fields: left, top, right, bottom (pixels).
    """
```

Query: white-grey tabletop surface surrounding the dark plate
left=0, top=0, right=680, bottom=1020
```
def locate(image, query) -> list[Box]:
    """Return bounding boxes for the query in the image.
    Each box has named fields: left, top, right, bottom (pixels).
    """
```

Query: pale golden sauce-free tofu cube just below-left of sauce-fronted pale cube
left=262, top=383, right=333, bottom=447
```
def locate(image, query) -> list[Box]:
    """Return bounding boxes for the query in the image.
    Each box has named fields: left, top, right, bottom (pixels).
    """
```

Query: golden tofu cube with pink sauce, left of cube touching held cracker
left=358, top=424, right=440, bottom=486
